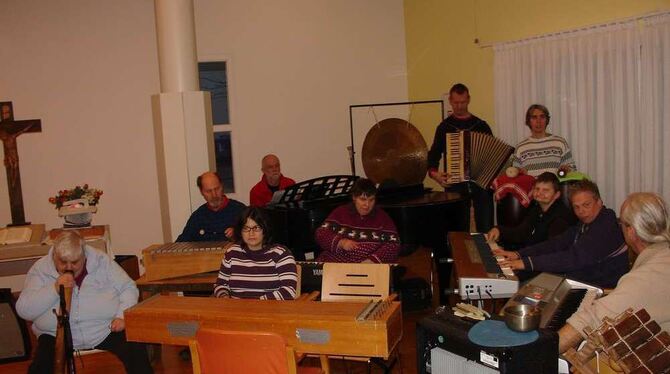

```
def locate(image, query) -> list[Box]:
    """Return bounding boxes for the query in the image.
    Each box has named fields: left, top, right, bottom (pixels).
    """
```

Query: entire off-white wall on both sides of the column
left=0, top=0, right=407, bottom=253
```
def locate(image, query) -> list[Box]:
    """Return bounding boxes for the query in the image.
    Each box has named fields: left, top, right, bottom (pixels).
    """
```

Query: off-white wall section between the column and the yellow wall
left=195, top=0, right=407, bottom=202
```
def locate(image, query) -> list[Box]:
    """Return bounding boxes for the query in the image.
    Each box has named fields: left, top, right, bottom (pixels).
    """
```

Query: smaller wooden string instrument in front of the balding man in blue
left=142, top=242, right=233, bottom=281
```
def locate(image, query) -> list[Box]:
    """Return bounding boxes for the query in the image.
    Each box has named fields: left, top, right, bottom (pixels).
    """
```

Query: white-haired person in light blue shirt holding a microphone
left=16, top=231, right=153, bottom=373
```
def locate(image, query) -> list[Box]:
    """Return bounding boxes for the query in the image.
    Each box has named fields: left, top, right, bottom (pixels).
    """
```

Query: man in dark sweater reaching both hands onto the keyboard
left=494, top=179, right=628, bottom=288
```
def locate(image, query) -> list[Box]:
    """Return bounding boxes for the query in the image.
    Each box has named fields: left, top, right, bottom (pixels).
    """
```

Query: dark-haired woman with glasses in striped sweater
left=214, top=207, right=298, bottom=300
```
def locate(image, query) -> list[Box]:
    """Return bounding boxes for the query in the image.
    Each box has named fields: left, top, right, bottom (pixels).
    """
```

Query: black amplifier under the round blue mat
left=416, top=310, right=558, bottom=374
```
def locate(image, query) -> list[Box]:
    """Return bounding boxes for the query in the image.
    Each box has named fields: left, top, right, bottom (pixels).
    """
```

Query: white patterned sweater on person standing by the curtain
left=512, top=134, right=577, bottom=177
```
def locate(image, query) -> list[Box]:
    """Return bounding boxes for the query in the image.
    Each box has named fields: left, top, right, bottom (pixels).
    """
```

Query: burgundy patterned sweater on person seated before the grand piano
left=315, top=203, right=400, bottom=263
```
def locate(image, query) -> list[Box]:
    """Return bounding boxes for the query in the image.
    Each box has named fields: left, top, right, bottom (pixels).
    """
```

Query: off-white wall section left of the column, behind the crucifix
left=0, top=0, right=161, bottom=253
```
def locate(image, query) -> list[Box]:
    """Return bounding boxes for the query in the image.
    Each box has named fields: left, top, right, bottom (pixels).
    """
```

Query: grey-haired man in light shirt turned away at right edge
left=558, top=192, right=670, bottom=353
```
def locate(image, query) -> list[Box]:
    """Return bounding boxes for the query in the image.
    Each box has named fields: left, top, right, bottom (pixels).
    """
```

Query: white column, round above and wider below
left=152, top=0, right=216, bottom=242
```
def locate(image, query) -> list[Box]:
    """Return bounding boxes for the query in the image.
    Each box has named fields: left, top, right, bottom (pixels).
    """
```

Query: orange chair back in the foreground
left=189, top=328, right=322, bottom=374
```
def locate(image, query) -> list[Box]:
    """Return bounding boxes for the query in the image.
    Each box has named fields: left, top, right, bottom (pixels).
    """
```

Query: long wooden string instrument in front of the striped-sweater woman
left=124, top=295, right=402, bottom=359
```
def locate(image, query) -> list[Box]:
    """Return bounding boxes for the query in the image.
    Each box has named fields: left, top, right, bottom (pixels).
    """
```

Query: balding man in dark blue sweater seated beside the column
left=177, top=172, right=246, bottom=242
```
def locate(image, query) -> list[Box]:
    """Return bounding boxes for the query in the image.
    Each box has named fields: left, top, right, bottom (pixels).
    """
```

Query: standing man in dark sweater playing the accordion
left=428, top=83, right=493, bottom=232
